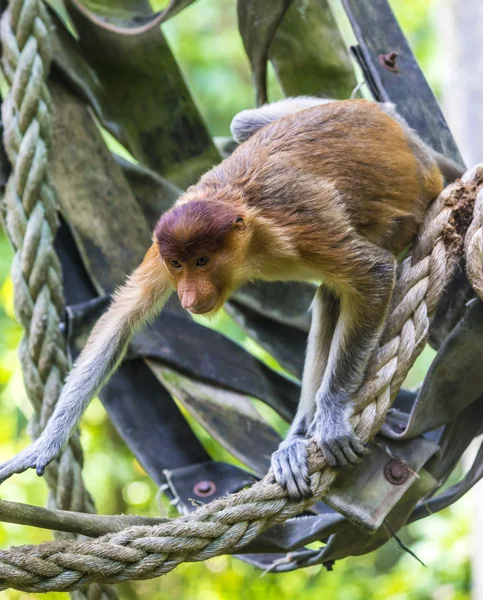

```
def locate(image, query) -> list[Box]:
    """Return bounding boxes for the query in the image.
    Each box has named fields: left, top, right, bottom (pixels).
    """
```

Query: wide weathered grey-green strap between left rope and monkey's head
left=50, top=81, right=151, bottom=295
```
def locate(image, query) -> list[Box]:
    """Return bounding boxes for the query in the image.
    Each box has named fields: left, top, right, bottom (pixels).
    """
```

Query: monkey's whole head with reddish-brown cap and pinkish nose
left=154, top=200, right=249, bottom=315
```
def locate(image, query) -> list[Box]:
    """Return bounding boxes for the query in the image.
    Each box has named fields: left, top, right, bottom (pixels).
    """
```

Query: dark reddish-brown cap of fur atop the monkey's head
left=154, top=200, right=239, bottom=260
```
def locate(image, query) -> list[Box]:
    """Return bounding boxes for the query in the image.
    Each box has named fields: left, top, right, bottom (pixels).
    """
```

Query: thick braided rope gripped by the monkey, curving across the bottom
left=0, top=165, right=483, bottom=592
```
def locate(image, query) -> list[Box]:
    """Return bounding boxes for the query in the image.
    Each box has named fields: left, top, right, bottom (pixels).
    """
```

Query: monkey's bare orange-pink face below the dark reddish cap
left=164, top=252, right=231, bottom=315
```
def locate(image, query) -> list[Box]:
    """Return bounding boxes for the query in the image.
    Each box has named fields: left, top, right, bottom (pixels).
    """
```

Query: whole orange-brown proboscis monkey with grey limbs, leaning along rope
left=0, top=98, right=462, bottom=500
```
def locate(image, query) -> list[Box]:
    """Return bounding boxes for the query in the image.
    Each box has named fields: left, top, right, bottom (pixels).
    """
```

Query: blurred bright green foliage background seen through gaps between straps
left=0, top=0, right=472, bottom=600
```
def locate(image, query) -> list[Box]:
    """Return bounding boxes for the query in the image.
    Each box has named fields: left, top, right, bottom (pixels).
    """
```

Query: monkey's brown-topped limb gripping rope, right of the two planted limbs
left=308, top=244, right=395, bottom=467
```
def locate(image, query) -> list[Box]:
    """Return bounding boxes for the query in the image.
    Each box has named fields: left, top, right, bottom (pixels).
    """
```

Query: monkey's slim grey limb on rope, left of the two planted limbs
left=272, top=285, right=339, bottom=501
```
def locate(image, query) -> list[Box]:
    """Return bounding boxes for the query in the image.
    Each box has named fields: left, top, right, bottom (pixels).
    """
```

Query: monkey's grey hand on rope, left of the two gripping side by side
left=272, top=437, right=313, bottom=502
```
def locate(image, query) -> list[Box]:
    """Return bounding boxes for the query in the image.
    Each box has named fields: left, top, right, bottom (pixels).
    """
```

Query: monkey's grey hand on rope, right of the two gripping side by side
left=307, top=403, right=369, bottom=468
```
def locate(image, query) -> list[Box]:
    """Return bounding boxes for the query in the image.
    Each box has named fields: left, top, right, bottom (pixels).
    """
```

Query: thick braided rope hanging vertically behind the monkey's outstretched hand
left=0, top=0, right=115, bottom=600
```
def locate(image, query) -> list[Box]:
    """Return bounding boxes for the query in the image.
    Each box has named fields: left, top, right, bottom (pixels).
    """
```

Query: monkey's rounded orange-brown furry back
left=207, top=100, right=443, bottom=253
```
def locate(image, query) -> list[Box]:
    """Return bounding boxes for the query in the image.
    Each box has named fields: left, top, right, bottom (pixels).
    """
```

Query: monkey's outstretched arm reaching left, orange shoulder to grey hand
left=0, top=245, right=172, bottom=481
